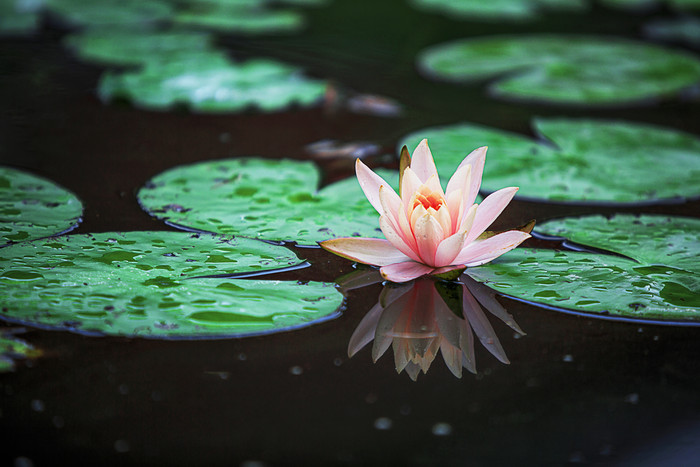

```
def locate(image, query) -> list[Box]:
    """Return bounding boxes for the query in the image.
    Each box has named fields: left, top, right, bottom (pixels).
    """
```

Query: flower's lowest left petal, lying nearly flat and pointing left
left=319, top=237, right=410, bottom=266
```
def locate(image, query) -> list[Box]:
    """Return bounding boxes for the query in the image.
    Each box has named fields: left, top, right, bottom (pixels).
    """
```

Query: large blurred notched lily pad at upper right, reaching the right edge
left=418, top=35, right=700, bottom=105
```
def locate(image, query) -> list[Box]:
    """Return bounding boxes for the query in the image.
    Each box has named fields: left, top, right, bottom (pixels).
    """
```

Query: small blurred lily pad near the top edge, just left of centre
left=173, top=4, right=304, bottom=34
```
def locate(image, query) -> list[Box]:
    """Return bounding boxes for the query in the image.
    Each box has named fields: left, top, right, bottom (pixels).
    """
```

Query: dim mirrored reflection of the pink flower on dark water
left=339, top=270, right=525, bottom=381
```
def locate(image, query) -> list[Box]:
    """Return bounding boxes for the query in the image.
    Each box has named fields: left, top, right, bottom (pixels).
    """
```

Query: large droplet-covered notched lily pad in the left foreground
left=0, top=232, right=342, bottom=338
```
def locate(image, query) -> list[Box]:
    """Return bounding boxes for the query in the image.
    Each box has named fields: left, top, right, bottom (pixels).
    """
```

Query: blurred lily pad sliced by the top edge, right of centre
left=411, top=0, right=588, bottom=21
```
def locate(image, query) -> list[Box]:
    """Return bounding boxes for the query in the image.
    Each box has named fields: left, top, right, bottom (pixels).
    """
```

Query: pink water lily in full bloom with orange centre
left=320, top=139, right=530, bottom=282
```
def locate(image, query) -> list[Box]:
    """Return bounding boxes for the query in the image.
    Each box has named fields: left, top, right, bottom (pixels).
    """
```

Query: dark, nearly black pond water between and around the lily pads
left=0, top=0, right=700, bottom=465
